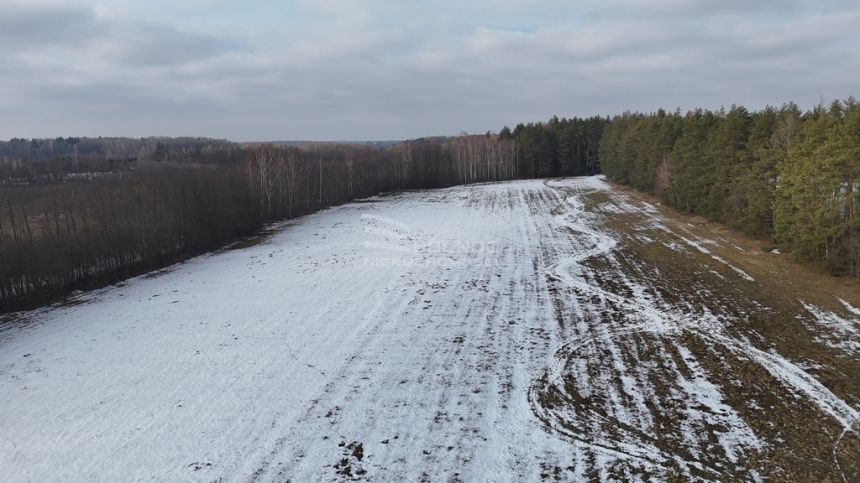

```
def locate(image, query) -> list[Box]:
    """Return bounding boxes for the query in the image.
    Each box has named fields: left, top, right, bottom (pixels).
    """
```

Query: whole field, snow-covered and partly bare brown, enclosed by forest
left=0, top=178, right=860, bottom=481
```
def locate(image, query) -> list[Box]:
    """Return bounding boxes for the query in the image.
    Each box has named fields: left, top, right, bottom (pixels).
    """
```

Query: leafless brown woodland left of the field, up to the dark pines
left=0, top=134, right=517, bottom=312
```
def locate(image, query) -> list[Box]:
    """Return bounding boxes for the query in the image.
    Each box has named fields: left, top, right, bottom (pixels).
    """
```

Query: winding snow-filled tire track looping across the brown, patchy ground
left=529, top=181, right=860, bottom=478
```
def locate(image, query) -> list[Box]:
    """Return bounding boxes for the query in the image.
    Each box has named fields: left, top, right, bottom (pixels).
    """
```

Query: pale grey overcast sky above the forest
left=0, top=0, right=860, bottom=141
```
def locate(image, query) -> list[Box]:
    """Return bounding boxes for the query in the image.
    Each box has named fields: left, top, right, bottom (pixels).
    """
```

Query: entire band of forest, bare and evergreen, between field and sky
left=0, top=99, right=860, bottom=312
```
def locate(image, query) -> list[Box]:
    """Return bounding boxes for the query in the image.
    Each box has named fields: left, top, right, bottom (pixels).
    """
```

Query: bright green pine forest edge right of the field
left=599, top=98, right=860, bottom=277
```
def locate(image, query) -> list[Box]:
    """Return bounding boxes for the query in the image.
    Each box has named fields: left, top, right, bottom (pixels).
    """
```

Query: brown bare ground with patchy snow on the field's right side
left=531, top=182, right=860, bottom=481
